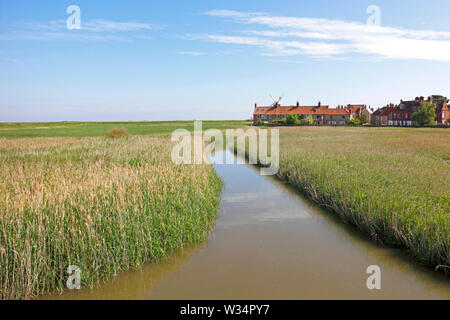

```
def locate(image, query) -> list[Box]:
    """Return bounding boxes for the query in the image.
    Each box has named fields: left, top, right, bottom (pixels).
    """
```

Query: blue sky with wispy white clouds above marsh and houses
left=0, top=0, right=450, bottom=121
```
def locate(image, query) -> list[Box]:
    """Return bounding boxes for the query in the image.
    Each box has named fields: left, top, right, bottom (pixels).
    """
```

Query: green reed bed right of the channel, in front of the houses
left=272, top=127, right=450, bottom=273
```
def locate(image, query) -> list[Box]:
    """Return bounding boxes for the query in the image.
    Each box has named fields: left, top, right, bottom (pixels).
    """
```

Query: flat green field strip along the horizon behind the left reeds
left=0, top=120, right=250, bottom=138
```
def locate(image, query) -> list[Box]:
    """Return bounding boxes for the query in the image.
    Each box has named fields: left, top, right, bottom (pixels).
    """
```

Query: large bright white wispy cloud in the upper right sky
left=198, top=10, right=450, bottom=61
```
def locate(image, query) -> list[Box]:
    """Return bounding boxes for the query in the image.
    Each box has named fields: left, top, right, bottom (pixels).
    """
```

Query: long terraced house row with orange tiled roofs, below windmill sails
left=253, top=102, right=371, bottom=125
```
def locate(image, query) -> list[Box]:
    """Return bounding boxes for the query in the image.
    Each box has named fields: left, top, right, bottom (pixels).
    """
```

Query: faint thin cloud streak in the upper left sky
left=0, top=19, right=161, bottom=41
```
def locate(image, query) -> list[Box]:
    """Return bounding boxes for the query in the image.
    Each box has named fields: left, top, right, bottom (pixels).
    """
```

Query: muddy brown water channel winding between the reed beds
left=42, top=153, right=450, bottom=299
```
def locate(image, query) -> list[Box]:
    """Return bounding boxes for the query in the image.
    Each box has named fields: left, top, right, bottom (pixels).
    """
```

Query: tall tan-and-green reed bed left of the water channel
left=0, top=134, right=222, bottom=299
